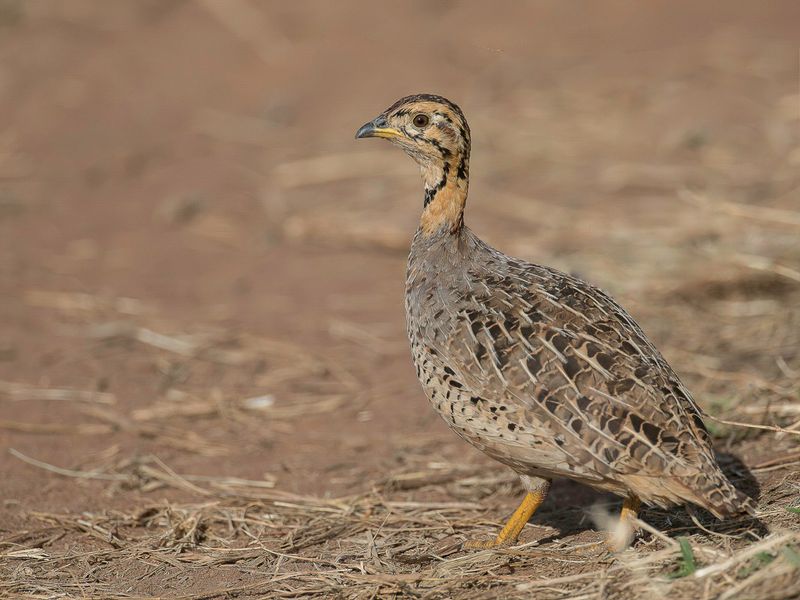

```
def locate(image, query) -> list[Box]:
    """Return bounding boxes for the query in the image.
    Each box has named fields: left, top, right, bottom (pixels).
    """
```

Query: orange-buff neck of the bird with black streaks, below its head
left=419, top=157, right=469, bottom=237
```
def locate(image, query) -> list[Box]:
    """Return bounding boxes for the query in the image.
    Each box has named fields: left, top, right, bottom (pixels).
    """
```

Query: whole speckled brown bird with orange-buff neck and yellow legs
left=356, top=94, right=755, bottom=550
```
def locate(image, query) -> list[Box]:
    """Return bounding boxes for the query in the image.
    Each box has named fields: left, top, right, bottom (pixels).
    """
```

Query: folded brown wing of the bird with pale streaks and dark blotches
left=451, top=257, right=714, bottom=477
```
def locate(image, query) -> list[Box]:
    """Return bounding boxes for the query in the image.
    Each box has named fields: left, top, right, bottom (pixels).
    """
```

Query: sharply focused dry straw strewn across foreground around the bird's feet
left=0, top=456, right=800, bottom=599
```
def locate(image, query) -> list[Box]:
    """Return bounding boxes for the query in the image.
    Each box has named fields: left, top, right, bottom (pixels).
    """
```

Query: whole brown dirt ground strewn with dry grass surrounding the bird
left=0, top=0, right=800, bottom=599
